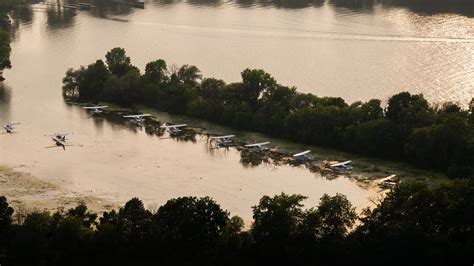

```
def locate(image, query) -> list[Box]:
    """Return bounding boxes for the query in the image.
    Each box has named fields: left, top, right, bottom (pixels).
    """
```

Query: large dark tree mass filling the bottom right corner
left=354, top=181, right=474, bottom=264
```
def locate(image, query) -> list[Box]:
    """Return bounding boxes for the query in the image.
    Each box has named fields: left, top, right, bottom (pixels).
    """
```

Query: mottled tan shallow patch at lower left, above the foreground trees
left=0, top=165, right=119, bottom=213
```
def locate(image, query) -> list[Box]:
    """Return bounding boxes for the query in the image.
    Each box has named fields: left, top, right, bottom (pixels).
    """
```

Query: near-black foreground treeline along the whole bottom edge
left=0, top=180, right=474, bottom=265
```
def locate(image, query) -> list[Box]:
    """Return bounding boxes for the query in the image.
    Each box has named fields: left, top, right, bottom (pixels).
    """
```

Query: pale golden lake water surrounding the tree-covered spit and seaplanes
left=0, top=1, right=468, bottom=220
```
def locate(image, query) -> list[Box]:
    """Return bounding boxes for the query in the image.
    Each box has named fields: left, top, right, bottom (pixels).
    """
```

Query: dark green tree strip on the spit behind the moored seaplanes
left=63, top=48, right=474, bottom=178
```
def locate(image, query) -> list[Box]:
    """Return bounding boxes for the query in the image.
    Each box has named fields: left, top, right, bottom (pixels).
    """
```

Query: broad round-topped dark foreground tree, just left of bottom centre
left=153, top=197, right=229, bottom=265
